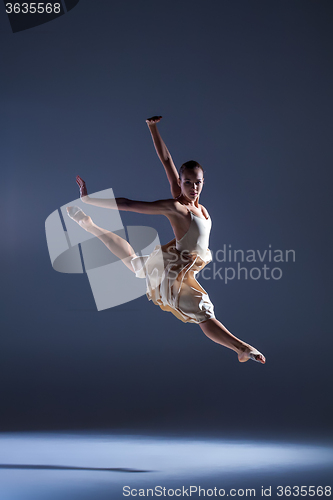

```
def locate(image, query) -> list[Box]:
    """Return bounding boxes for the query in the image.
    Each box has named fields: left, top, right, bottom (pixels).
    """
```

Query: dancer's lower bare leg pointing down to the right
left=199, top=318, right=266, bottom=363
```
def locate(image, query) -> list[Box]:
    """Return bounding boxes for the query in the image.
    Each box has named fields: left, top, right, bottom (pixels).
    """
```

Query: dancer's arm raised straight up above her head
left=146, top=116, right=181, bottom=198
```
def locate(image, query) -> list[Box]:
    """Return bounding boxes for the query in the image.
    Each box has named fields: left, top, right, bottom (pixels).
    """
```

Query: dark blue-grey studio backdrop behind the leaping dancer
left=0, top=0, right=333, bottom=436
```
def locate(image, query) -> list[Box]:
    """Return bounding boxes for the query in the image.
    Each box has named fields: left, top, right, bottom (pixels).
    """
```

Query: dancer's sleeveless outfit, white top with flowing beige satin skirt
left=131, top=210, right=215, bottom=323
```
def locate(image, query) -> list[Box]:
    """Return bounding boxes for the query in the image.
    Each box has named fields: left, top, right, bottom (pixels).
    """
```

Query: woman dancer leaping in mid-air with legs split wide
left=67, top=116, right=266, bottom=363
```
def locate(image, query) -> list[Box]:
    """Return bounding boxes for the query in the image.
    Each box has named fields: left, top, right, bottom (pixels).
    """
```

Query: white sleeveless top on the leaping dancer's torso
left=176, top=209, right=212, bottom=260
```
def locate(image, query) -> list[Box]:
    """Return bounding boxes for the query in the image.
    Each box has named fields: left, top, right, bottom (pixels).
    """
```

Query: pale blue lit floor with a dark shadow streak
left=0, top=433, right=333, bottom=500
